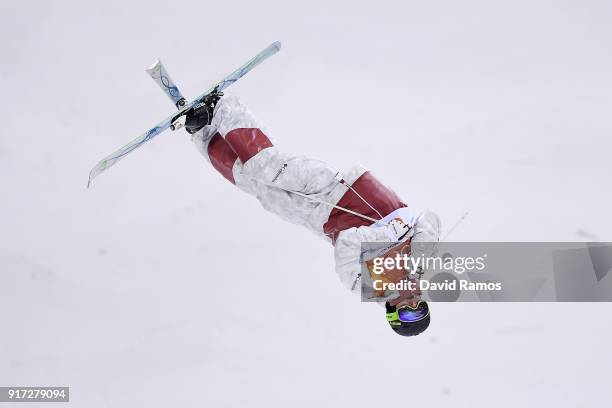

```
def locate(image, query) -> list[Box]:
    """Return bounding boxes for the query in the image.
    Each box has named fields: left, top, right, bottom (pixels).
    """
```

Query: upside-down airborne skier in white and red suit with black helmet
left=185, top=92, right=440, bottom=336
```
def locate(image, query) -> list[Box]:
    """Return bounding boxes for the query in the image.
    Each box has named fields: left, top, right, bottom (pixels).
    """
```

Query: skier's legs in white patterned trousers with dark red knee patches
left=194, top=93, right=343, bottom=231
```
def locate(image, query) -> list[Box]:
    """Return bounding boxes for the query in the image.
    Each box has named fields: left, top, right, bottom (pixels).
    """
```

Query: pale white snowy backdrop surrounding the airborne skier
left=0, top=0, right=612, bottom=408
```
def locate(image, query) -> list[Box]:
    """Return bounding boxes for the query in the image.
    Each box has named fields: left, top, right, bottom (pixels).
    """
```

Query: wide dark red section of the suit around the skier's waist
left=323, top=171, right=407, bottom=244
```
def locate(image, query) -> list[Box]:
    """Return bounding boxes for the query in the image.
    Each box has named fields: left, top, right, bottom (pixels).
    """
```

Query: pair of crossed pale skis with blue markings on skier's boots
left=87, top=41, right=281, bottom=187
